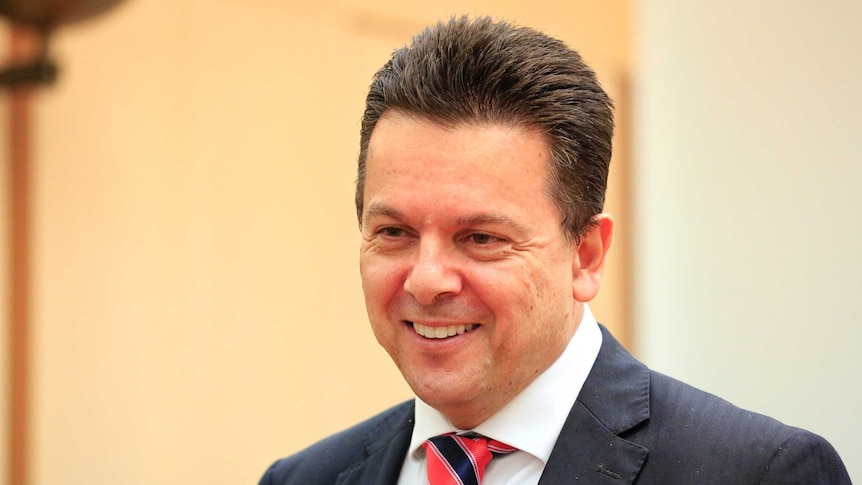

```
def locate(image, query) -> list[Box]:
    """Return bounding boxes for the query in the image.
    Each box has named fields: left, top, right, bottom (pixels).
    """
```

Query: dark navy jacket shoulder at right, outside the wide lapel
left=640, top=371, right=850, bottom=484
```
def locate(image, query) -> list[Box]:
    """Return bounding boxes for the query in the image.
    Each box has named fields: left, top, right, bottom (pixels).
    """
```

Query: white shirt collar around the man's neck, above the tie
left=407, top=304, right=602, bottom=463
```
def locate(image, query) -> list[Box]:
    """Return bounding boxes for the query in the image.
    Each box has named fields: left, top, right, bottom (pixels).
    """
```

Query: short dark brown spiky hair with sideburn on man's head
left=356, top=17, right=614, bottom=240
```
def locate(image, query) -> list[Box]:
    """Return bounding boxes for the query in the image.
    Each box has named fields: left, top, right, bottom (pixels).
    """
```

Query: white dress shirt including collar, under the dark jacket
left=398, top=304, right=602, bottom=485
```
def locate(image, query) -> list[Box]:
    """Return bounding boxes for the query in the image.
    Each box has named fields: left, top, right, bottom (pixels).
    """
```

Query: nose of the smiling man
left=404, top=241, right=462, bottom=305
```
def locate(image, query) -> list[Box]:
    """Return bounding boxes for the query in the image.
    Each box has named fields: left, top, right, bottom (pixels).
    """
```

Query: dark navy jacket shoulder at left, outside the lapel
left=260, top=400, right=414, bottom=485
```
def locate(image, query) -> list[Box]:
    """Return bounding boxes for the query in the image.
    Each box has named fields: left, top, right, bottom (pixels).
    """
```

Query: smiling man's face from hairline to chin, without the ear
left=360, top=112, right=583, bottom=428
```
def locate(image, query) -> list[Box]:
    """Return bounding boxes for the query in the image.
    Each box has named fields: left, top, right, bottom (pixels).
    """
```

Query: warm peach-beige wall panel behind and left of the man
left=0, top=0, right=628, bottom=485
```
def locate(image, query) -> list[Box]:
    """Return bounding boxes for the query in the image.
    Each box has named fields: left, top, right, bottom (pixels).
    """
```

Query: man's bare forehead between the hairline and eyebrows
left=364, top=112, right=556, bottom=227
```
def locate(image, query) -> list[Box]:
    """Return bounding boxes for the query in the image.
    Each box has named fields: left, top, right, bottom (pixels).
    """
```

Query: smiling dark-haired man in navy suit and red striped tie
left=261, top=18, right=850, bottom=485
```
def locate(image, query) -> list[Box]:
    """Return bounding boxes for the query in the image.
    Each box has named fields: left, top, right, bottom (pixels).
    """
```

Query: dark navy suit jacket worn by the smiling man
left=260, top=327, right=851, bottom=485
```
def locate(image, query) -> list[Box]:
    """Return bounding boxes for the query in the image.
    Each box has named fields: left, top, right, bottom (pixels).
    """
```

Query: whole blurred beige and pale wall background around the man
left=0, top=0, right=862, bottom=485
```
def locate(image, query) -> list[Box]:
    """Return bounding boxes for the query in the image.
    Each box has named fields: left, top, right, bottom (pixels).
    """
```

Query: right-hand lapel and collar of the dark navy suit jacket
left=539, top=327, right=649, bottom=485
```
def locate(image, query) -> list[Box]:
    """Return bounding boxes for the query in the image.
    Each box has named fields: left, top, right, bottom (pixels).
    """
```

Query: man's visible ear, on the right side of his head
left=572, top=213, right=614, bottom=302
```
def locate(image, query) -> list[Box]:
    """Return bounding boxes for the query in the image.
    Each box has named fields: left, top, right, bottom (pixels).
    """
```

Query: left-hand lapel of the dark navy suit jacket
left=336, top=400, right=415, bottom=485
